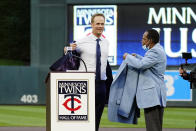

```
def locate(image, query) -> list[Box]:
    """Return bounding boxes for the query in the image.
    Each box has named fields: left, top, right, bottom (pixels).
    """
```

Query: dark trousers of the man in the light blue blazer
left=144, top=106, right=164, bottom=131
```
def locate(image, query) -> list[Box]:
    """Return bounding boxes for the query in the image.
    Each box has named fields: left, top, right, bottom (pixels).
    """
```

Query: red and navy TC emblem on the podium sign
left=63, top=94, right=81, bottom=114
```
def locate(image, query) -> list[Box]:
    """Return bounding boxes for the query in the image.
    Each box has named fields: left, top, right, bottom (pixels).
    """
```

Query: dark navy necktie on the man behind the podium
left=96, top=39, right=101, bottom=80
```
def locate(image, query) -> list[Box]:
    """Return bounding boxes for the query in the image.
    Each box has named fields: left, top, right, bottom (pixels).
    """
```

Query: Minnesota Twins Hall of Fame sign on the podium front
left=58, top=80, right=88, bottom=120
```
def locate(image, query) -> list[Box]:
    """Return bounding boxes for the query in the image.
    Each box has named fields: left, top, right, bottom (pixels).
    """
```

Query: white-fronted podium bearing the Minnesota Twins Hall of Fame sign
left=46, top=72, right=95, bottom=131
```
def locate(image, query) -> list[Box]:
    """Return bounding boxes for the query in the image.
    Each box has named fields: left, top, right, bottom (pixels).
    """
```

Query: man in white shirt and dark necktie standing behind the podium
left=67, top=14, right=109, bottom=131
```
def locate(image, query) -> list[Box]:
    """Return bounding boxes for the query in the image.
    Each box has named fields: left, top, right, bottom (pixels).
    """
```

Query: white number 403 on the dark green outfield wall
left=20, top=94, right=38, bottom=104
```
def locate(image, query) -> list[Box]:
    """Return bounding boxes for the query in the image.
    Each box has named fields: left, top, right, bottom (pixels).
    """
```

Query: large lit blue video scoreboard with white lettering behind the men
left=69, top=4, right=196, bottom=66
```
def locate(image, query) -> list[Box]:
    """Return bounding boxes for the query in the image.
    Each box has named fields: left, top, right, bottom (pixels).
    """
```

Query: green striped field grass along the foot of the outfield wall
left=0, top=105, right=196, bottom=128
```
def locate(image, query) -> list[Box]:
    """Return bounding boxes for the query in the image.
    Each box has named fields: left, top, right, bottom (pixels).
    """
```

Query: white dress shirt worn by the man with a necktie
left=76, top=33, right=109, bottom=80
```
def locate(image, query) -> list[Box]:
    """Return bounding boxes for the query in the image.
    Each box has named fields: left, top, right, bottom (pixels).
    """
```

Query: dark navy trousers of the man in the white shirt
left=95, top=81, right=106, bottom=131
